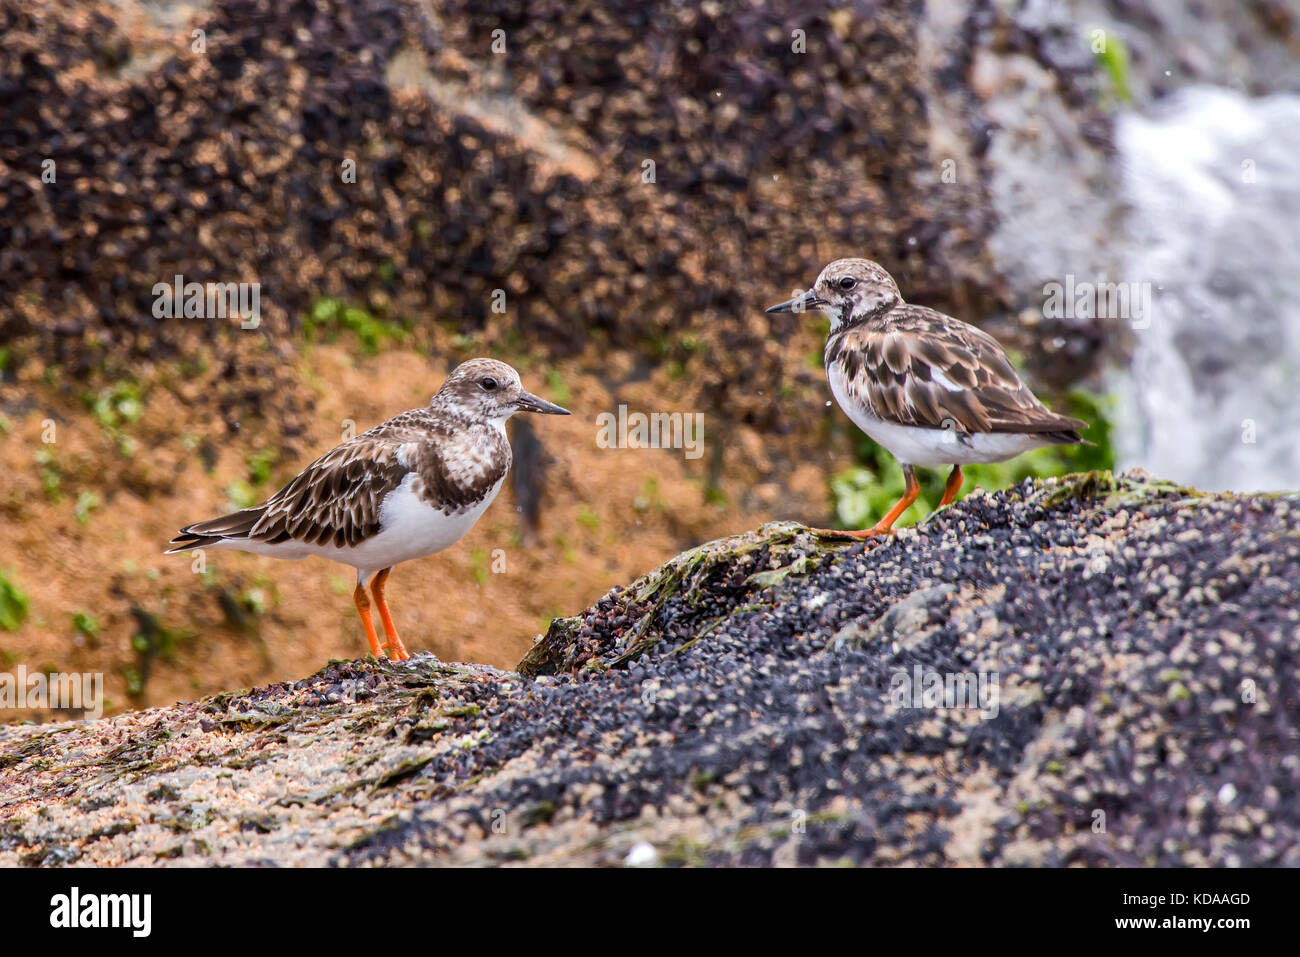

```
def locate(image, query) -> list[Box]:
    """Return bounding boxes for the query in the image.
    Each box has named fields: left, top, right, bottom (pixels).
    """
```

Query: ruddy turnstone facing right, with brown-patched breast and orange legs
left=168, top=359, right=568, bottom=661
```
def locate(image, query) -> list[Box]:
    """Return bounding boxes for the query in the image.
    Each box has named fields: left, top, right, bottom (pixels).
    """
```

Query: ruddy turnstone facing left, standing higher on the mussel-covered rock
left=767, top=259, right=1088, bottom=537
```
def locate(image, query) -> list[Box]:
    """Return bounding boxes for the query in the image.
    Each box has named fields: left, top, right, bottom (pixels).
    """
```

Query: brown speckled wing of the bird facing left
left=826, top=306, right=1087, bottom=438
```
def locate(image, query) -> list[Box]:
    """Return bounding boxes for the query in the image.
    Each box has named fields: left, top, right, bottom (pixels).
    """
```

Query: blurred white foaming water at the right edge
left=1117, top=87, right=1300, bottom=492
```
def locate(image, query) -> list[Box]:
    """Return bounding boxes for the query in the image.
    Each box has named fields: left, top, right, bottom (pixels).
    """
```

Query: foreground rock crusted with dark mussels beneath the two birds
left=0, top=473, right=1300, bottom=866
